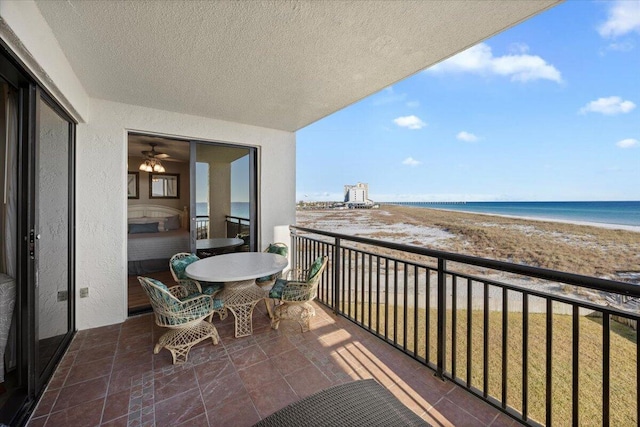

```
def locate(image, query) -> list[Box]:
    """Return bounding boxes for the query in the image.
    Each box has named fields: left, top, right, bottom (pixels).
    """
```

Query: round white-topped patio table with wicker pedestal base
left=185, top=252, right=289, bottom=338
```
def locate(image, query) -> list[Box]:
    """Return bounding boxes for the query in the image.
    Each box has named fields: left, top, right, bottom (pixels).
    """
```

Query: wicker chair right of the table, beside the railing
left=267, top=256, right=328, bottom=332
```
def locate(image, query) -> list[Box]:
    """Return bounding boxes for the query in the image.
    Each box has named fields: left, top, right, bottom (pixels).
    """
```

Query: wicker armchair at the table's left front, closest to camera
left=138, top=276, right=222, bottom=364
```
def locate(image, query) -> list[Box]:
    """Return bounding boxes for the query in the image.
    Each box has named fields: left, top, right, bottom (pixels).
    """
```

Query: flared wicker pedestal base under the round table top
left=218, top=279, right=267, bottom=338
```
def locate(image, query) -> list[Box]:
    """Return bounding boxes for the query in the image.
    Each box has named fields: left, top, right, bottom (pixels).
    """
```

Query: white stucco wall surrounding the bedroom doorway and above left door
left=0, top=0, right=295, bottom=329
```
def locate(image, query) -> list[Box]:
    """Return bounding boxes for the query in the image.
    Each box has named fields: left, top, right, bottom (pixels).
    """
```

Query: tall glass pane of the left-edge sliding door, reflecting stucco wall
left=30, top=94, right=74, bottom=385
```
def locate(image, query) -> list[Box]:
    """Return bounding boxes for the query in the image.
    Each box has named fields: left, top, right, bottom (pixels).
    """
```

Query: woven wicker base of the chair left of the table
left=153, top=320, right=220, bottom=365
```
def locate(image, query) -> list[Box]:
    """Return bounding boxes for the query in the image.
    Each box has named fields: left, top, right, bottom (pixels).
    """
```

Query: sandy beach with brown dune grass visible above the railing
left=297, top=206, right=640, bottom=283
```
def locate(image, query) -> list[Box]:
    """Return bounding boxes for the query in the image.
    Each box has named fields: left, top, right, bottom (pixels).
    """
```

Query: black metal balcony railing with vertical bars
left=291, top=226, right=640, bottom=426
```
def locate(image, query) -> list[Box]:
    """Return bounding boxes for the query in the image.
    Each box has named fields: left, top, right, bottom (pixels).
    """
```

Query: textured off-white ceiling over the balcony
left=36, top=0, right=557, bottom=131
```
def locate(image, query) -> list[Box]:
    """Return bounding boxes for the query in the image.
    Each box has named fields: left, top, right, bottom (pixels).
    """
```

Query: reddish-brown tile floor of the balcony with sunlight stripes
left=28, top=304, right=518, bottom=427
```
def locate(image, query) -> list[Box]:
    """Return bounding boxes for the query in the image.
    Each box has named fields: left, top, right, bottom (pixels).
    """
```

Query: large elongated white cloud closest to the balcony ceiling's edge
left=427, top=43, right=562, bottom=83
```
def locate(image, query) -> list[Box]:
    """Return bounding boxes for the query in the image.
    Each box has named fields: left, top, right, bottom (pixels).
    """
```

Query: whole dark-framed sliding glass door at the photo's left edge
left=0, top=46, right=75, bottom=425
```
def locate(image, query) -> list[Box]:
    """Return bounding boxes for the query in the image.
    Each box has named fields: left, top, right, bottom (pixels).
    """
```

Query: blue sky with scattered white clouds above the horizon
left=296, top=0, right=640, bottom=201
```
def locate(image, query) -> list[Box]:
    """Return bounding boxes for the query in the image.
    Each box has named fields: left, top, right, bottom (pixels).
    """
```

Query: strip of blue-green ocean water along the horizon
left=389, top=201, right=640, bottom=226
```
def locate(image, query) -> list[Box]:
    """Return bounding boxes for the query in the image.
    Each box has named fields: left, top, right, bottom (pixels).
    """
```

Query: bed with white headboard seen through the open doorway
left=127, top=205, right=191, bottom=275
